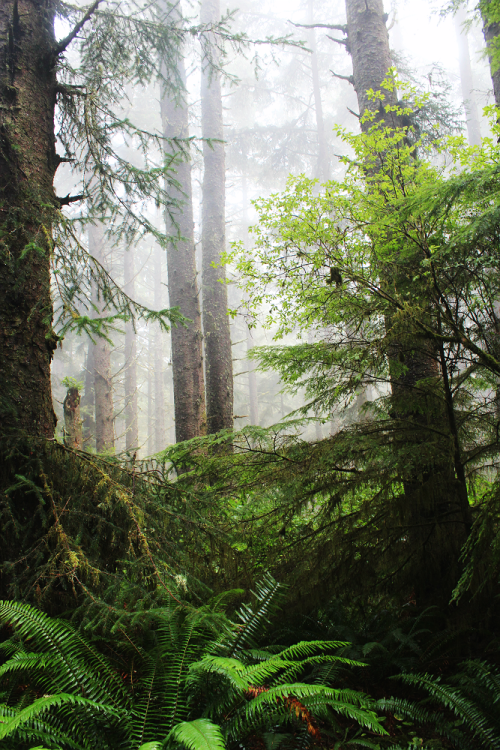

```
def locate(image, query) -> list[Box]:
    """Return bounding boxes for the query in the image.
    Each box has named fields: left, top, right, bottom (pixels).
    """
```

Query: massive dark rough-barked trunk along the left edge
left=0, top=0, right=58, bottom=438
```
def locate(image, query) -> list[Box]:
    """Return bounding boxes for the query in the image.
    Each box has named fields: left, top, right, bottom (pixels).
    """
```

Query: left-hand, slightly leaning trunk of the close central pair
left=161, top=51, right=206, bottom=442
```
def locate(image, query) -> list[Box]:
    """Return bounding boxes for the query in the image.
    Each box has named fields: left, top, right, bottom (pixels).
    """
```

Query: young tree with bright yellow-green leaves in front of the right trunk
left=225, top=94, right=500, bottom=601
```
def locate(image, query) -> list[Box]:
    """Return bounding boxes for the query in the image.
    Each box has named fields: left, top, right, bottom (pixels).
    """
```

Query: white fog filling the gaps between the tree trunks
left=52, top=0, right=493, bottom=457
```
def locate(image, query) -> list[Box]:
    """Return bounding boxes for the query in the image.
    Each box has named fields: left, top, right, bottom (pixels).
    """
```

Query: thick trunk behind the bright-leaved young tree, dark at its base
left=346, top=0, right=470, bottom=601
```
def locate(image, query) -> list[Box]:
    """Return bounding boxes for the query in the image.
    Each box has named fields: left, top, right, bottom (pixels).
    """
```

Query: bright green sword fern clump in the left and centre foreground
left=0, top=577, right=384, bottom=750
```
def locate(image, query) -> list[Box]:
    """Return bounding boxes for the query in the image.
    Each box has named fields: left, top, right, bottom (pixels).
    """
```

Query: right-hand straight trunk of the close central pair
left=201, top=0, right=233, bottom=433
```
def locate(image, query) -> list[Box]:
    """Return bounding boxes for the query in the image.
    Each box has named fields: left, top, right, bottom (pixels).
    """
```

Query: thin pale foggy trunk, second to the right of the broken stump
left=123, top=247, right=139, bottom=453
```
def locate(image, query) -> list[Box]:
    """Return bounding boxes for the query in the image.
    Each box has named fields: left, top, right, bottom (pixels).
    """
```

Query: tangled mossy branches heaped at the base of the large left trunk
left=0, top=438, right=217, bottom=629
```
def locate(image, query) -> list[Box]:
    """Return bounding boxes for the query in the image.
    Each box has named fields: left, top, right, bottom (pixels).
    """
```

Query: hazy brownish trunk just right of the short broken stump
left=89, top=223, right=115, bottom=453
